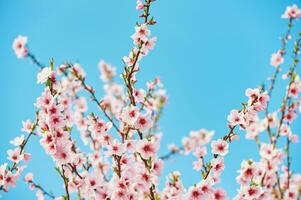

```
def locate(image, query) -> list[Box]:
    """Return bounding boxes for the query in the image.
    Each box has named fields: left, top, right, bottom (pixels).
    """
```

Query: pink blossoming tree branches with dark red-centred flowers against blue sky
left=0, top=0, right=301, bottom=200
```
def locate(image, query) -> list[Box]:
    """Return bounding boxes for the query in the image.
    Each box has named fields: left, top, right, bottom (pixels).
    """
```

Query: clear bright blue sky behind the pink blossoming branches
left=0, top=0, right=301, bottom=199
